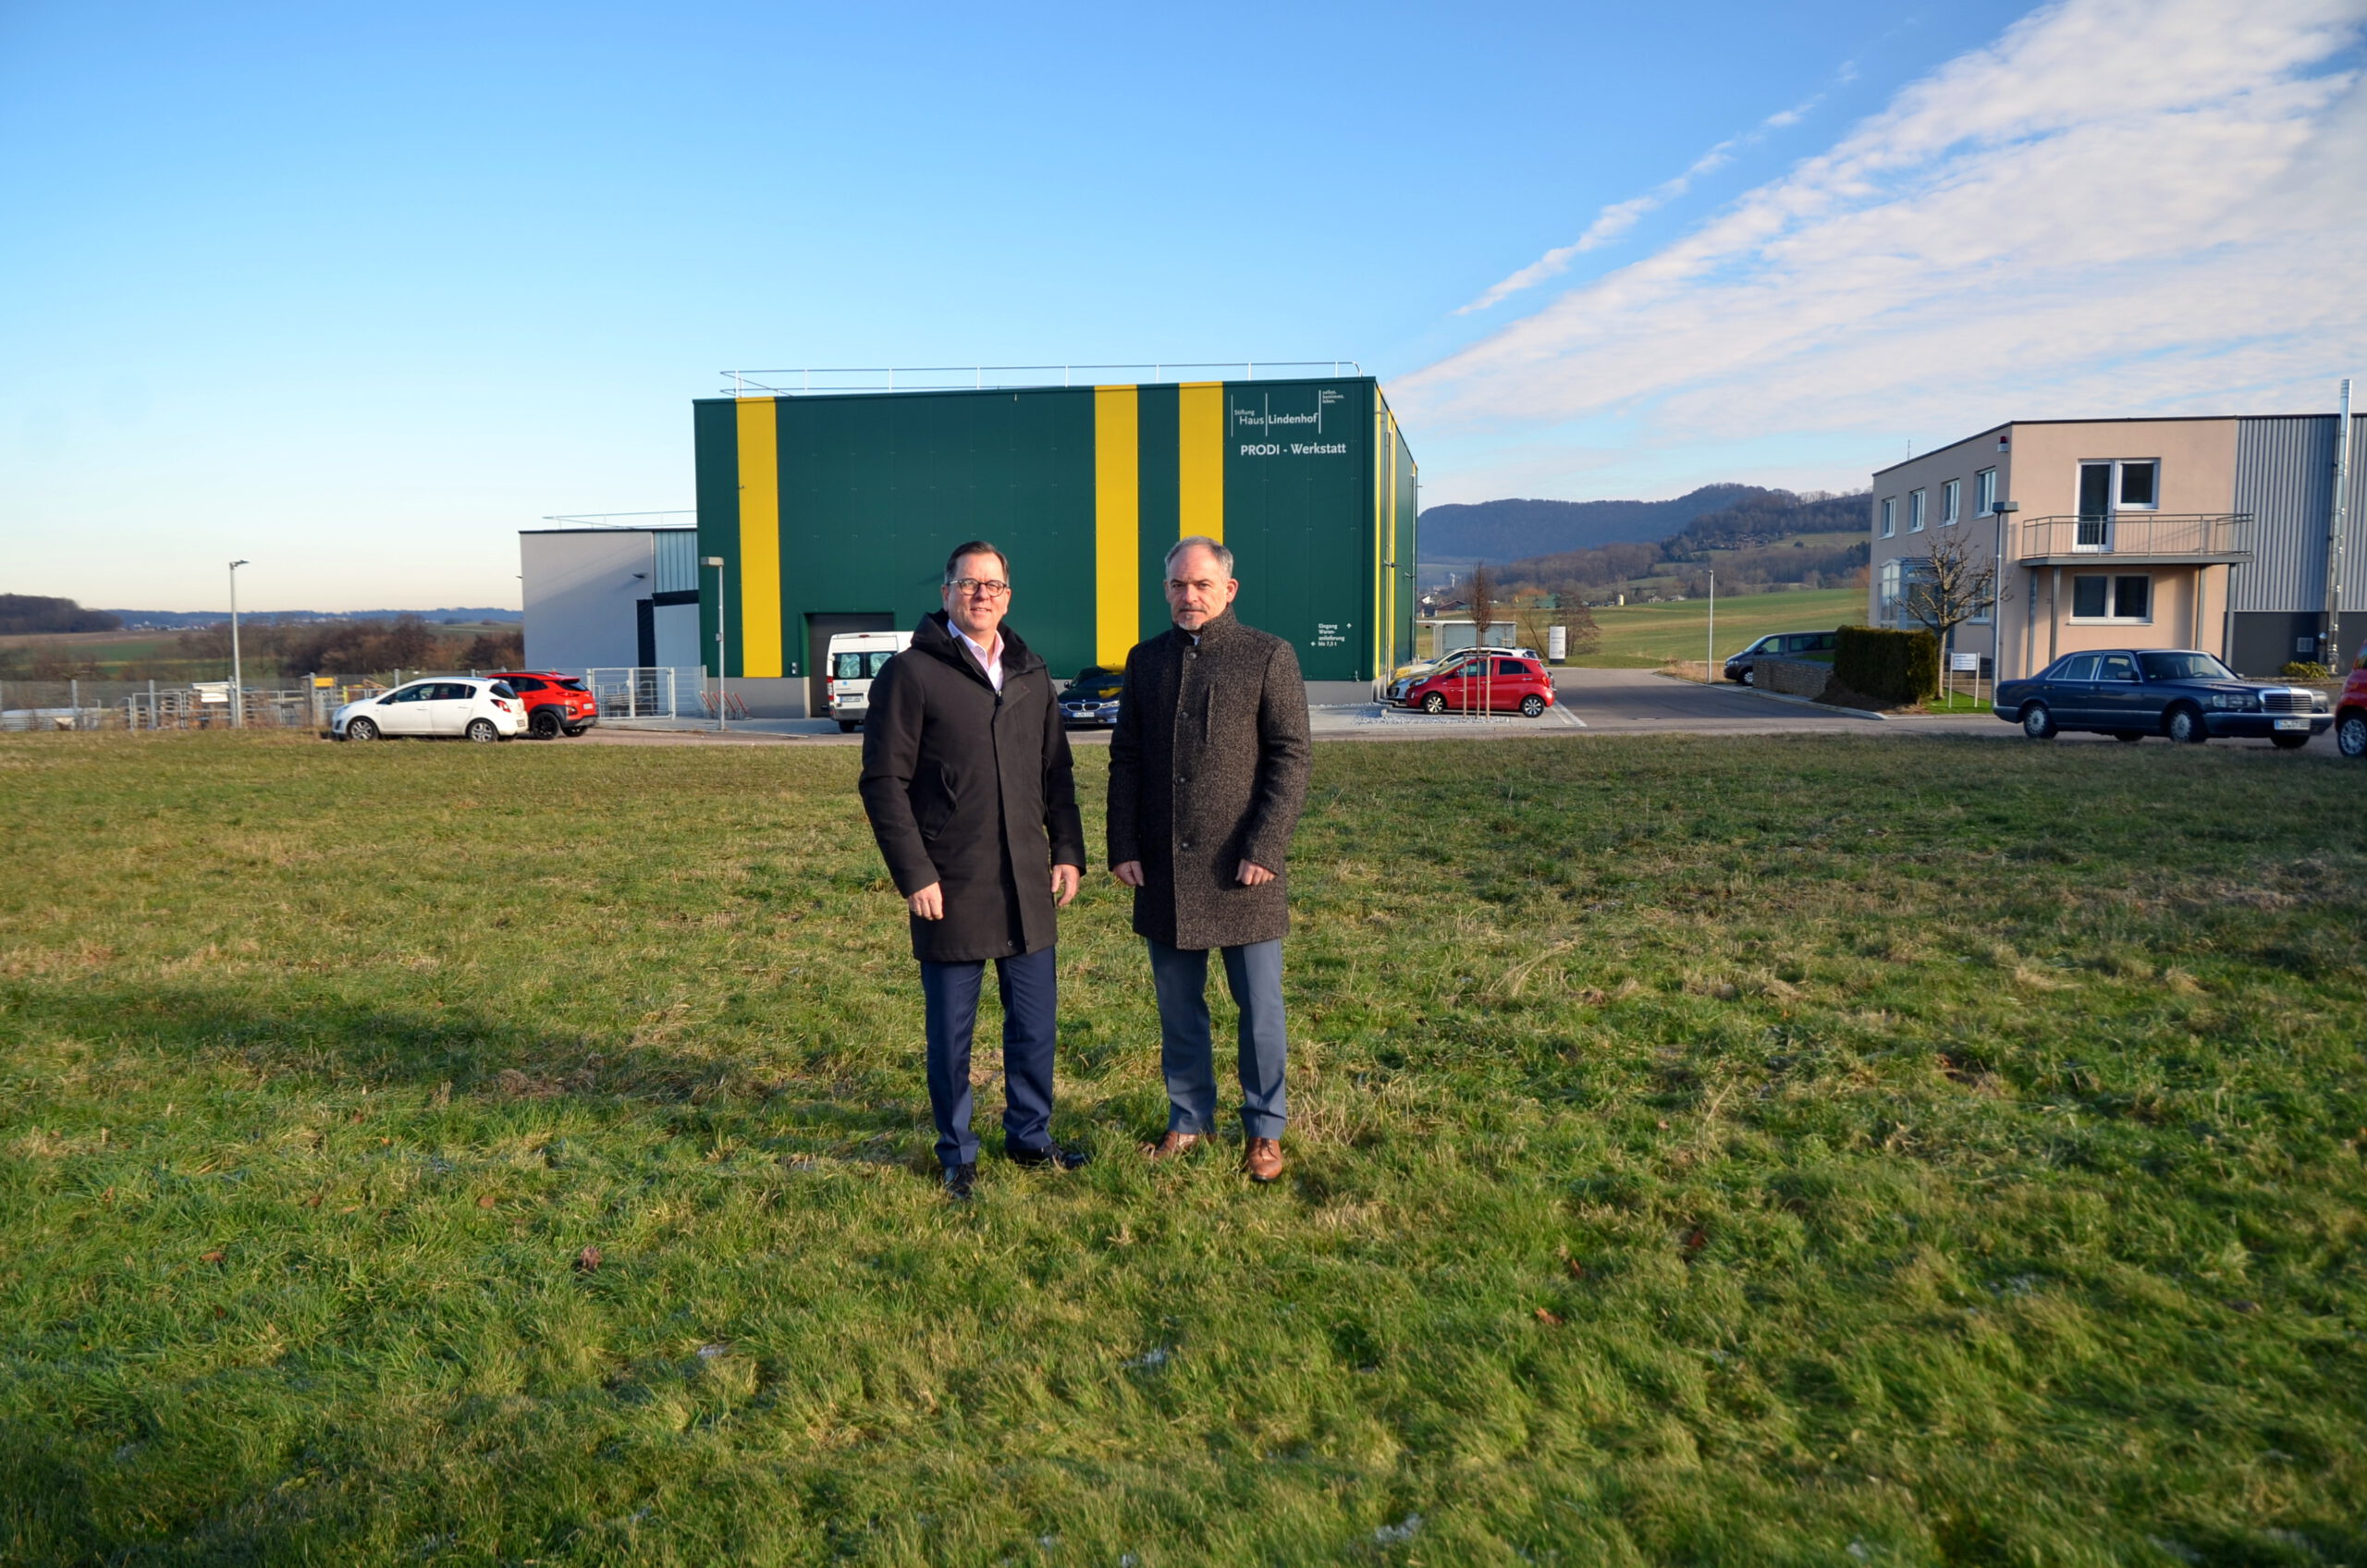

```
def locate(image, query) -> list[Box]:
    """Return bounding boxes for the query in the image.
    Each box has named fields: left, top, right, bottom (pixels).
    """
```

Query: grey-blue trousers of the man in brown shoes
left=1143, top=938, right=1290, bottom=1137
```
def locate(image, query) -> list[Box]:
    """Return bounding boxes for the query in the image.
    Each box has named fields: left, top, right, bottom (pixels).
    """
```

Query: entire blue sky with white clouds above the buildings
left=0, top=0, right=2367, bottom=608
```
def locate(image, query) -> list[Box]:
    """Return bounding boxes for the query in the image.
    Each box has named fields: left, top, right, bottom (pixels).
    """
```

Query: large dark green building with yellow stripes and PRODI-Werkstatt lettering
left=693, top=376, right=1417, bottom=716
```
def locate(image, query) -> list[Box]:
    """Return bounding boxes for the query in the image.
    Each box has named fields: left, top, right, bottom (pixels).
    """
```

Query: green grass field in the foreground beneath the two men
left=0, top=734, right=2367, bottom=1568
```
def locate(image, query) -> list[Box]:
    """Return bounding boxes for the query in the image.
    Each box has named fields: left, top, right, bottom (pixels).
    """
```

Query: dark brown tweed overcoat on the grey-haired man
left=1110, top=611, right=1309, bottom=949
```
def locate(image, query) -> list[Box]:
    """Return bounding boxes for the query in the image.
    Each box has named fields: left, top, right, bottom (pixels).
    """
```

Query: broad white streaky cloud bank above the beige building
left=1392, top=0, right=2367, bottom=485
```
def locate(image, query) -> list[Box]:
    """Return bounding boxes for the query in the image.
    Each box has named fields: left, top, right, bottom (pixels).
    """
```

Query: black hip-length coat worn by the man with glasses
left=859, top=611, right=1084, bottom=964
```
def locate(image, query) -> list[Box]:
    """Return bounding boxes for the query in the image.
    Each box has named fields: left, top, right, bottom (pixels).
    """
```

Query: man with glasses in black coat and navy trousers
left=862, top=540, right=1086, bottom=1198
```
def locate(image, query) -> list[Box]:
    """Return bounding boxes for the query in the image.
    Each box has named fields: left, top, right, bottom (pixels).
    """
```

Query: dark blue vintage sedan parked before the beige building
left=1991, top=649, right=2334, bottom=751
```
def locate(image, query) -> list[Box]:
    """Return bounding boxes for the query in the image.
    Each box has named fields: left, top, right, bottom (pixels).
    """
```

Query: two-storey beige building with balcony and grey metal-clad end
left=1868, top=414, right=2367, bottom=680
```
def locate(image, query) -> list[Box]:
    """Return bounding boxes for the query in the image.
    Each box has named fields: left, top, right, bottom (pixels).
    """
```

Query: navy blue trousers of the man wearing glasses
left=921, top=948, right=1061, bottom=1165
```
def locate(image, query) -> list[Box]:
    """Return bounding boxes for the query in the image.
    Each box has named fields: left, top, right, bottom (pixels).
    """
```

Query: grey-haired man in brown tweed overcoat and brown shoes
left=1110, top=535, right=1306, bottom=1182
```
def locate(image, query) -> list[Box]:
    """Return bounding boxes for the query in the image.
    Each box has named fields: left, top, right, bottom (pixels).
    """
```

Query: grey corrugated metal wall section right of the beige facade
left=2230, top=414, right=2367, bottom=616
